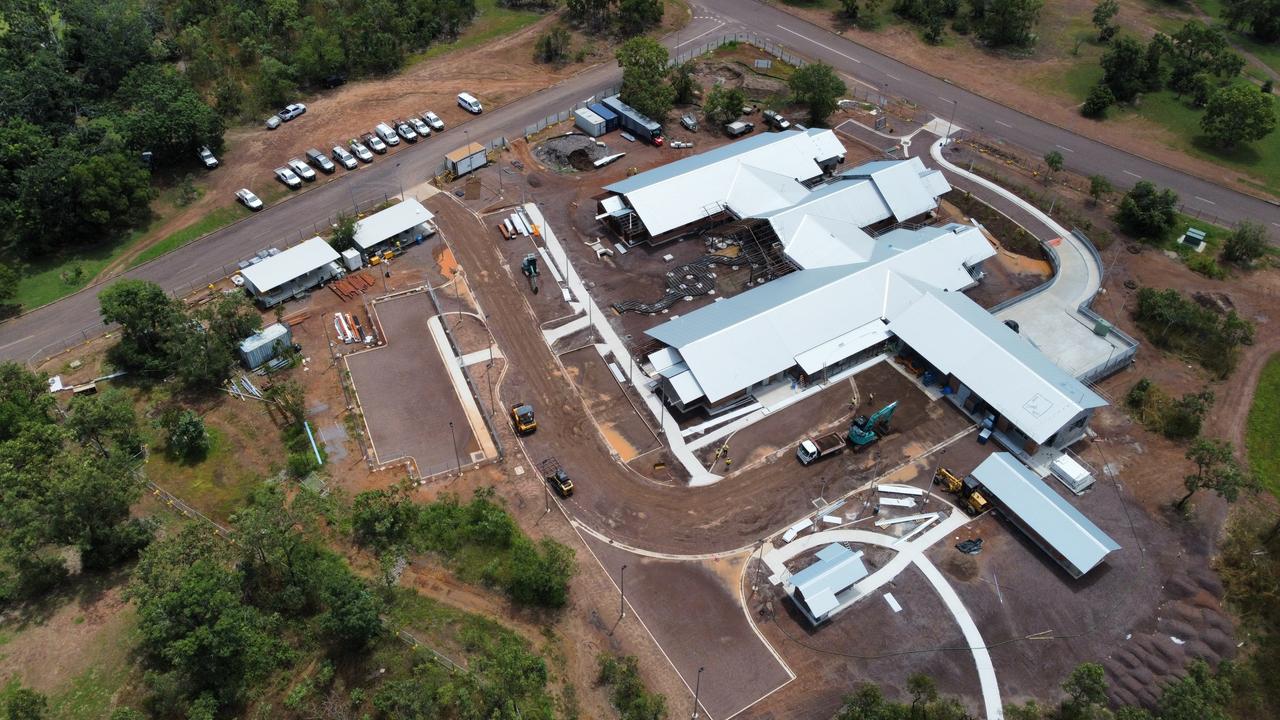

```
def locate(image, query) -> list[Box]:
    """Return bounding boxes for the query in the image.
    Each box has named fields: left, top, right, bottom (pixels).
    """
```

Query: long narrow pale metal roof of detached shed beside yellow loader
left=973, top=452, right=1120, bottom=575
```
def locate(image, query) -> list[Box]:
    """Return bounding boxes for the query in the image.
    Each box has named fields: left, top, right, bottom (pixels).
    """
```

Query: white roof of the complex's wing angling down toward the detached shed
left=888, top=288, right=1106, bottom=443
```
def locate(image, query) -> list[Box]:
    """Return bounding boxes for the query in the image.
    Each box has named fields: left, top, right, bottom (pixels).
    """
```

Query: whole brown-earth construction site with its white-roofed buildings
left=15, top=105, right=1249, bottom=720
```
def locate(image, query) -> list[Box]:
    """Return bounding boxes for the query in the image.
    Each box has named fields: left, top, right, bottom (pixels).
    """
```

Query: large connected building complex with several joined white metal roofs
left=598, top=129, right=1106, bottom=454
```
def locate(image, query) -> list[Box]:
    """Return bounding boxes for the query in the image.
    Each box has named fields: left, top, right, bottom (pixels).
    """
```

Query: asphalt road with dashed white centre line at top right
left=695, top=0, right=1280, bottom=224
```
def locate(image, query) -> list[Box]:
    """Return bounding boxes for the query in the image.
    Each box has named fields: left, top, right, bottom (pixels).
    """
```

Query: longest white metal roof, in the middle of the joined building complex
left=646, top=225, right=995, bottom=402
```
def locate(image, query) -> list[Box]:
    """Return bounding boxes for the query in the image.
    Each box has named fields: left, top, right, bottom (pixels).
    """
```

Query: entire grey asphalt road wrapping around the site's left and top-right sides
left=0, top=0, right=1280, bottom=361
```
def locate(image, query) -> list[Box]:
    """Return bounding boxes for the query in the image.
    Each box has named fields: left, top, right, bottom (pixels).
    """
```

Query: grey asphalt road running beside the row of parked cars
left=0, top=18, right=718, bottom=363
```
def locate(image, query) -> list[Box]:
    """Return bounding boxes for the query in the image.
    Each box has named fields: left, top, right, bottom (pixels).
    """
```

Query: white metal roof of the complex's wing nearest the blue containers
left=605, top=129, right=845, bottom=236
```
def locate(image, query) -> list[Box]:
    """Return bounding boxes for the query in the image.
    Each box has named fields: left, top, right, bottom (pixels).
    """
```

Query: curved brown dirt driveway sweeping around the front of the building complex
left=428, top=193, right=969, bottom=553
